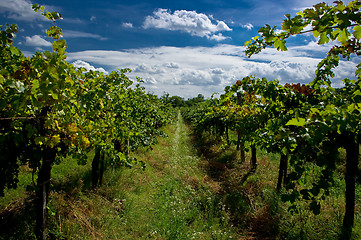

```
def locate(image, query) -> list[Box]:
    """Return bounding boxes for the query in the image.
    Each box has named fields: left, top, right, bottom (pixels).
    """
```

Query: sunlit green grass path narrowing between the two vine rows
left=93, top=110, right=239, bottom=239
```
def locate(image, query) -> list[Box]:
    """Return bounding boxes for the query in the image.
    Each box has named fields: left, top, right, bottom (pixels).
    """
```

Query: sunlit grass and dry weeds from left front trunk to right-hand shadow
left=45, top=111, right=239, bottom=239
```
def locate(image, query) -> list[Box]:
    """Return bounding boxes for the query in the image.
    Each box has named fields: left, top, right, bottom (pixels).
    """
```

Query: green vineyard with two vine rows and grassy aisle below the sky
left=0, top=1, right=361, bottom=239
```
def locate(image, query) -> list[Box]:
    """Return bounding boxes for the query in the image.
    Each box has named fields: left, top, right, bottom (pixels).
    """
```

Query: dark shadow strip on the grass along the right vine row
left=188, top=127, right=279, bottom=239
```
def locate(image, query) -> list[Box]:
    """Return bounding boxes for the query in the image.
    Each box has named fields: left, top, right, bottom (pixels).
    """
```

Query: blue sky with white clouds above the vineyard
left=0, top=0, right=361, bottom=99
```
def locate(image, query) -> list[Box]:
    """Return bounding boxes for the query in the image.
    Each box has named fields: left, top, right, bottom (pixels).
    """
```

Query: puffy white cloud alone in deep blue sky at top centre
left=143, top=8, right=232, bottom=41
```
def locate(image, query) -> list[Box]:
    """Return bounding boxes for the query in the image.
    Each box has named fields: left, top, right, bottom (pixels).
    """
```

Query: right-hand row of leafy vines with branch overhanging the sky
left=183, top=1, right=361, bottom=239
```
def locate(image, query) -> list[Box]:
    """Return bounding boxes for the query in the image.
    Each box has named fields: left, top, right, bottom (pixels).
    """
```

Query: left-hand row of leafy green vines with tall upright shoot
left=0, top=4, right=171, bottom=239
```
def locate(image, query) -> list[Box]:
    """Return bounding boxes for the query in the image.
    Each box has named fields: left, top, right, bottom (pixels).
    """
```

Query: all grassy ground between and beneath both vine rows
left=0, top=111, right=361, bottom=239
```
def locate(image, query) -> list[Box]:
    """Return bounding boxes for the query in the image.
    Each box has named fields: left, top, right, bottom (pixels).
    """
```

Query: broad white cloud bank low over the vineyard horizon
left=68, top=42, right=357, bottom=97
